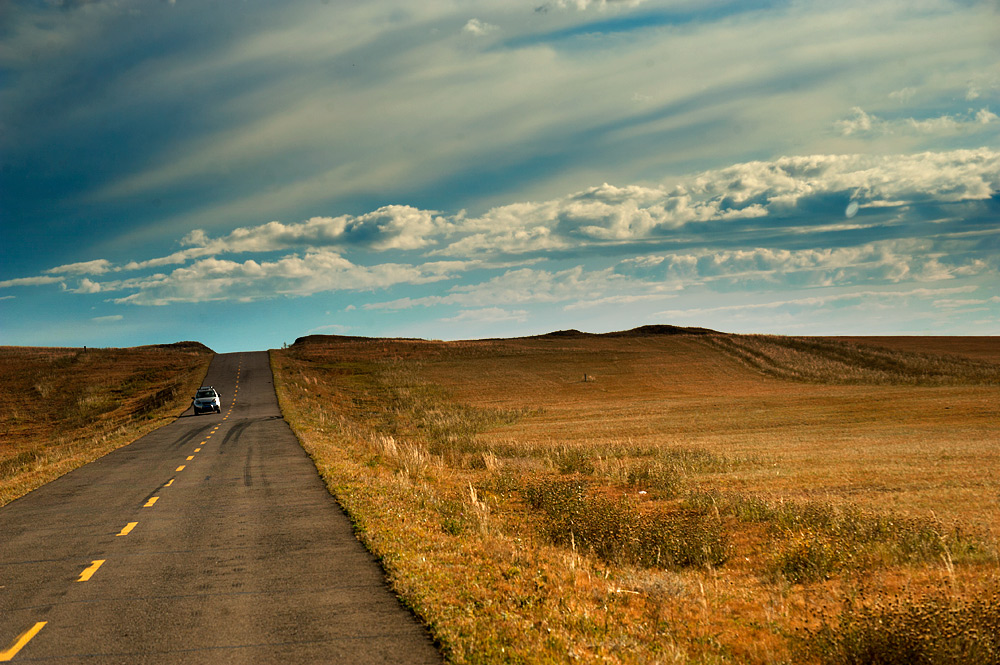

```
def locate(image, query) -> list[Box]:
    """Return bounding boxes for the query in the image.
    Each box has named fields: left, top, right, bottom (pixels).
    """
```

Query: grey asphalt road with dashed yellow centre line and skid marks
left=0, top=353, right=442, bottom=664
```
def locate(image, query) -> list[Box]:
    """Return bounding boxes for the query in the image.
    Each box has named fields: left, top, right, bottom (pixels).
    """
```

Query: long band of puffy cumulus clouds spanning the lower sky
left=0, top=148, right=1000, bottom=309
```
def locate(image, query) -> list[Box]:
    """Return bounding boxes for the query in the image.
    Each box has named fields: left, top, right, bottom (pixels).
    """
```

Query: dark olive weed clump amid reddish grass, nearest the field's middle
left=522, top=479, right=729, bottom=568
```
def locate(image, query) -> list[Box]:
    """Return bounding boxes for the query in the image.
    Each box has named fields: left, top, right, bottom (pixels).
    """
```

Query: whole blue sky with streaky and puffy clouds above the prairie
left=0, top=0, right=1000, bottom=352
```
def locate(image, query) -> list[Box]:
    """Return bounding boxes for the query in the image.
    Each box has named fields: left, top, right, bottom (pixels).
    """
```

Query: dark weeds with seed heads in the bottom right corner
left=793, top=593, right=1000, bottom=665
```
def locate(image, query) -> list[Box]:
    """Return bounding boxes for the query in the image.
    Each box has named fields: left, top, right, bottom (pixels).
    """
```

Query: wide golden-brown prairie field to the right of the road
left=272, top=335, right=1000, bottom=663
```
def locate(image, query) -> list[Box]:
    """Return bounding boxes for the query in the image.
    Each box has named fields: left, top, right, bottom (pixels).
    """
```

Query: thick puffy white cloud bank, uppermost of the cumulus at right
left=436, top=148, right=1000, bottom=255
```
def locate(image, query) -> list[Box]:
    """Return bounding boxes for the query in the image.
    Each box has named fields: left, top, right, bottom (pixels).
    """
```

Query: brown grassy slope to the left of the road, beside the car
left=0, top=343, right=212, bottom=506
